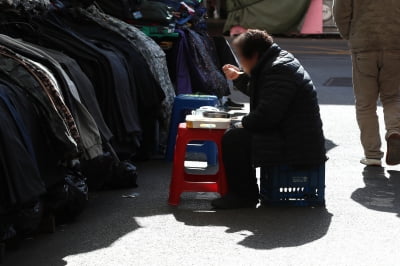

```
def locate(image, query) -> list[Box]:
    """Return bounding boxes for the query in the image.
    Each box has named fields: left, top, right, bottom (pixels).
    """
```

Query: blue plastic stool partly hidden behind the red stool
left=166, top=94, right=219, bottom=165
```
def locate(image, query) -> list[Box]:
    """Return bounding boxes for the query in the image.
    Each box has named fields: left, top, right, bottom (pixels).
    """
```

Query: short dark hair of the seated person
left=233, top=30, right=274, bottom=59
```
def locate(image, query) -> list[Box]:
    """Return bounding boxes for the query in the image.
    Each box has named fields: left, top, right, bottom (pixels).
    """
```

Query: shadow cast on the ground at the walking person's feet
left=351, top=167, right=400, bottom=217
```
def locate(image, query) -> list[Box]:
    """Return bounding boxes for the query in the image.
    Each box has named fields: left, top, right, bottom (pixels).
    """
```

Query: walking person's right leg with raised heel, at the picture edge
left=379, top=51, right=400, bottom=165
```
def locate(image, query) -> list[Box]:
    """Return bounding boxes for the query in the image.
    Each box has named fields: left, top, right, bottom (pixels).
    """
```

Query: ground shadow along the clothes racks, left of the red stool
left=1, top=161, right=171, bottom=266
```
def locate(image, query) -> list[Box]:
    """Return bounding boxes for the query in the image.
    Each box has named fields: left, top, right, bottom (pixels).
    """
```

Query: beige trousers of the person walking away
left=352, top=51, right=400, bottom=159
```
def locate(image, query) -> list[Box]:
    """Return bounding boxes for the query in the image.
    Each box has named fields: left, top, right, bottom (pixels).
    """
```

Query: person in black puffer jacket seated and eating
left=212, top=30, right=326, bottom=209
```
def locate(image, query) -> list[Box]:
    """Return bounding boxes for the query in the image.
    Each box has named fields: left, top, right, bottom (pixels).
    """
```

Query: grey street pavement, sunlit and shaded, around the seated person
left=5, top=39, right=400, bottom=266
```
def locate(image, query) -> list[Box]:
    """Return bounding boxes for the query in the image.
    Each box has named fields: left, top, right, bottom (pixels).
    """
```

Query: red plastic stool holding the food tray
left=168, top=123, right=227, bottom=205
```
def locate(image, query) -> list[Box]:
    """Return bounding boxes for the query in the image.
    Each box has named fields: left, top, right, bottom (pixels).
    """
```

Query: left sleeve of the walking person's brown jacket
left=333, top=0, right=353, bottom=40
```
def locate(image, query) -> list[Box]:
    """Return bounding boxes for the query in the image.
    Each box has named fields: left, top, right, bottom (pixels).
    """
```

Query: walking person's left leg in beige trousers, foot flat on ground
left=352, top=52, right=383, bottom=165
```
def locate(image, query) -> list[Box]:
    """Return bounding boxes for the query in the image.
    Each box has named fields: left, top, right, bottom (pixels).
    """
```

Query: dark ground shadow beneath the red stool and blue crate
left=174, top=207, right=333, bottom=250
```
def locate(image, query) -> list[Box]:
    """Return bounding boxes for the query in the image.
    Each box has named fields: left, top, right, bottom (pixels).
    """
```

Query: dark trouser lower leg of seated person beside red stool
left=222, top=128, right=259, bottom=200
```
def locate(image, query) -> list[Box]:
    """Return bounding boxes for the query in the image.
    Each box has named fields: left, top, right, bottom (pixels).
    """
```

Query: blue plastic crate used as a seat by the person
left=260, top=163, right=325, bottom=206
